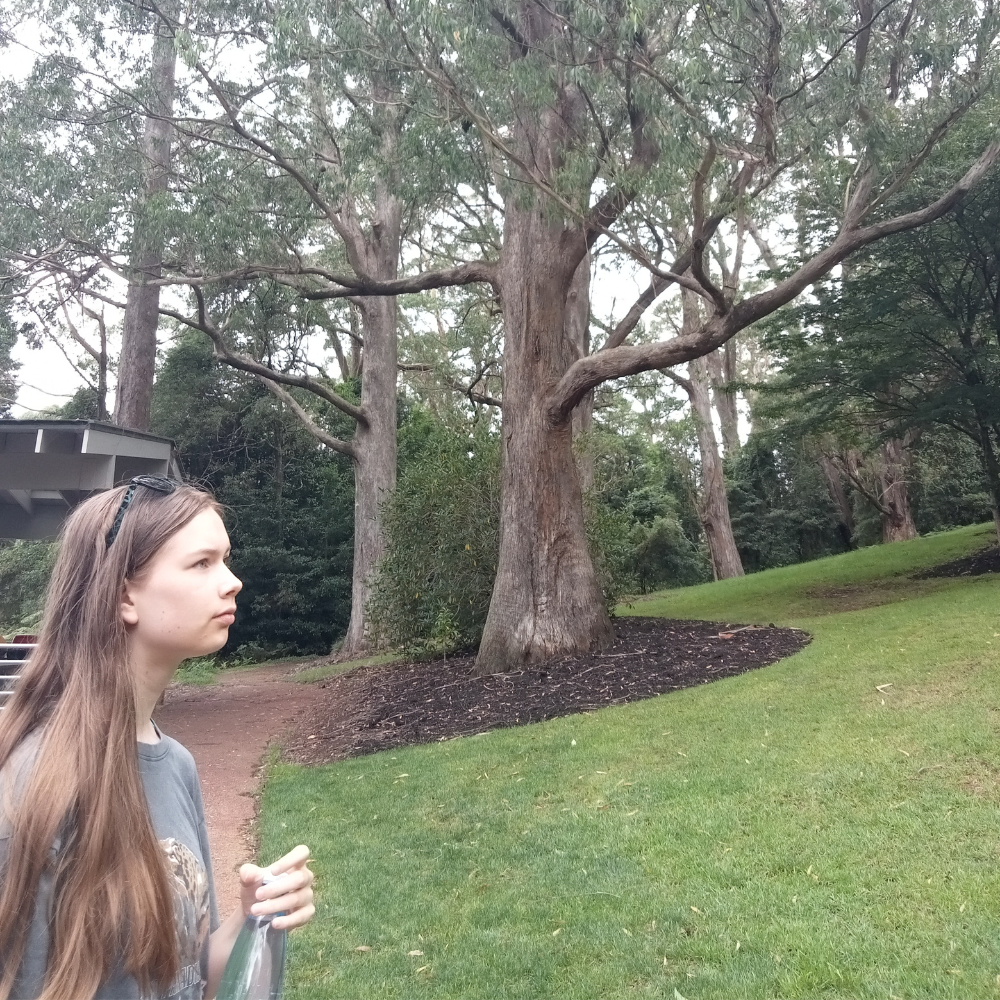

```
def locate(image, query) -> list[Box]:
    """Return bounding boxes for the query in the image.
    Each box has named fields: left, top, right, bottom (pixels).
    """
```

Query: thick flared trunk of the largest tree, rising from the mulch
left=476, top=216, right=614, bottom=675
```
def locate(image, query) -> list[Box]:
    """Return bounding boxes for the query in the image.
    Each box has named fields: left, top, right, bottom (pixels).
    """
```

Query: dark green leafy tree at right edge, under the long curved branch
left=767, top=165, right=1000, bottom=534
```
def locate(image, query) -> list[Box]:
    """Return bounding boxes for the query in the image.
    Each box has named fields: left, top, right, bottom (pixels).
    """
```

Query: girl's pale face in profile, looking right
left=121, top=510, right=243, bottom=666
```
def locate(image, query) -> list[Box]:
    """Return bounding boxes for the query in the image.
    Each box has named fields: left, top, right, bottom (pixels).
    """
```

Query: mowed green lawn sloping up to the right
left=261, top=528, right=1000, bottom=1000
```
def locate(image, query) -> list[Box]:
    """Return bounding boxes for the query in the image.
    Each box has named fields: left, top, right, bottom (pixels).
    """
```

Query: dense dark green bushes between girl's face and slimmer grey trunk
left=146, top=334, right=354, bottom=659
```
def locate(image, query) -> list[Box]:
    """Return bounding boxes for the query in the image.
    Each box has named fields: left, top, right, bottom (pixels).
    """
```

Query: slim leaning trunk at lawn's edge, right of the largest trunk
left=684, top=358, right=743, bottom=580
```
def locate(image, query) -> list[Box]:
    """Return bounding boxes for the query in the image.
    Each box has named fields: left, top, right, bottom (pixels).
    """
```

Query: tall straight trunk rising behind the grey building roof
left=114, top=0, right=179, bottom=431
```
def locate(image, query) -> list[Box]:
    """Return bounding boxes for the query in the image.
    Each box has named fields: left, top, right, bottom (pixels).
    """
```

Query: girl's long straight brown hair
left=0, top=486, right=218, bottom=1000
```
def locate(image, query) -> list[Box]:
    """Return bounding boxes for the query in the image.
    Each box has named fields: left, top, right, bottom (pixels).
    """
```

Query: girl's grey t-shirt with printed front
left=0, top=734, right=219, bottom=1000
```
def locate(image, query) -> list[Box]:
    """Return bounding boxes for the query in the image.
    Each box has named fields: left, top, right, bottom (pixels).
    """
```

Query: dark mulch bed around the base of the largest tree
left=285, top=618, right=810, bottom=764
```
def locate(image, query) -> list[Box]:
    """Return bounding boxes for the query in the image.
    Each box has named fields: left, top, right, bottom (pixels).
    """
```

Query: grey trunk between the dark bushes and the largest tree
left=342, top=184, right=403, bottom=656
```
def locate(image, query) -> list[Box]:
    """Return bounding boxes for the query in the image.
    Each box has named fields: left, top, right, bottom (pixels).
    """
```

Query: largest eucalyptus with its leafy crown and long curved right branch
left=366, top=0, right=1000, bottom=672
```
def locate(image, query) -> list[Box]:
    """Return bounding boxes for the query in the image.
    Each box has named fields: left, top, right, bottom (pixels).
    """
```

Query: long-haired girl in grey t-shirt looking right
left=0, top=476, right=314, bottom=1000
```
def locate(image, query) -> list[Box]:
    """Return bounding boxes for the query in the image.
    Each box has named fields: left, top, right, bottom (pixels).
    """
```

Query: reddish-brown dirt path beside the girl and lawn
left=155, top=662, right=325, bottom=918
